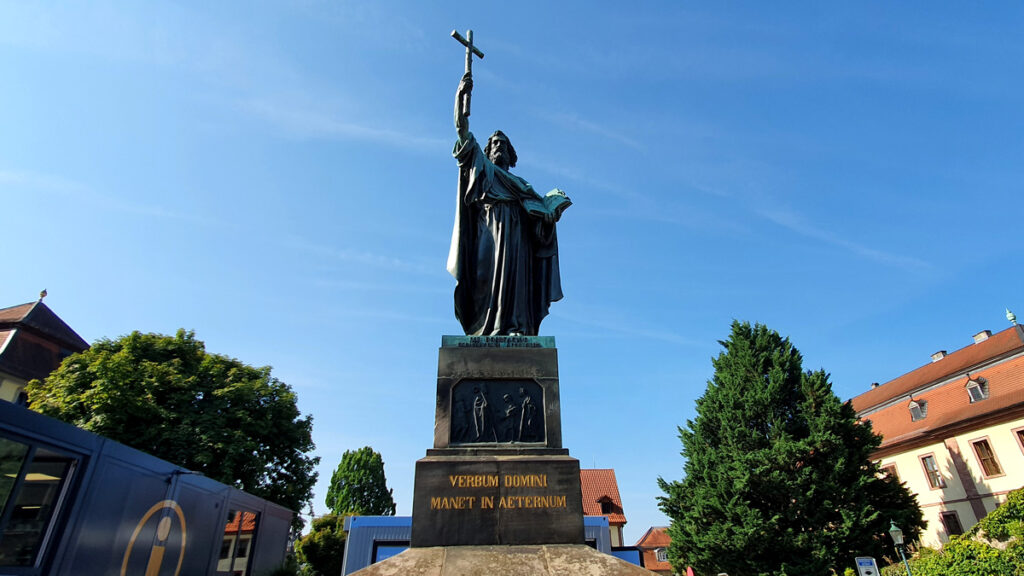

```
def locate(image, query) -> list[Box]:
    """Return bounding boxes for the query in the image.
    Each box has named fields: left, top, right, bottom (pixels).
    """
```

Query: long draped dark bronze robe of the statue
left=447, top=134, right=562, bottom=336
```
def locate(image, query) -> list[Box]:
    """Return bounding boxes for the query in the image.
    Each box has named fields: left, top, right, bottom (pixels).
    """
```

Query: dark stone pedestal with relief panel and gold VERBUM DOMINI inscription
left=411, top=336, right=584, bottom=547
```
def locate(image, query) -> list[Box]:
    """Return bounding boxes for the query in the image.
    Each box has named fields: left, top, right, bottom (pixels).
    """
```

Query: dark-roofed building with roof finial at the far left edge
left=0, top=297, right=89, bottom=404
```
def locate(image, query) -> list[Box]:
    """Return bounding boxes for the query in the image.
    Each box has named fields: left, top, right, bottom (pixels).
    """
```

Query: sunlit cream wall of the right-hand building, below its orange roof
left=880, top=418, right=1024, bottom=547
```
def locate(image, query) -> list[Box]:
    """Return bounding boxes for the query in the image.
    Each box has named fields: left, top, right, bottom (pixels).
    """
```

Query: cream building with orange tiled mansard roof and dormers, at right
left=851, top=324, right=1024, bottom=546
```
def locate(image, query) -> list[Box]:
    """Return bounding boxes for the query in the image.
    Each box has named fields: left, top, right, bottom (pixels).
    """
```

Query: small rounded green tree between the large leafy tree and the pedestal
left=327, top=446, right=394, bottom=516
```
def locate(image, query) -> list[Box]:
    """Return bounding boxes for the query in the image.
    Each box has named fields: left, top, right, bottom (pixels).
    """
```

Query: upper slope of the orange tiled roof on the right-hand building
left=851, top=326, right=1024, bottom=412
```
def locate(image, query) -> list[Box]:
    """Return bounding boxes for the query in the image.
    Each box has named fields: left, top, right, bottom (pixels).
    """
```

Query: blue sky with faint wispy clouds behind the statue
left=0, top=1, right=1024, bottom=542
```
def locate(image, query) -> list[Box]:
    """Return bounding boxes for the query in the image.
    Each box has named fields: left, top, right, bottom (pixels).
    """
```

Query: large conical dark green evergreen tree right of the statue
left=658, top=322, right=924, bottom=576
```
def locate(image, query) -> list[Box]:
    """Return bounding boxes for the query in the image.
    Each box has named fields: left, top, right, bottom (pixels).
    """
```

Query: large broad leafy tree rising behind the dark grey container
left=28, top=330, right=318, bottom=522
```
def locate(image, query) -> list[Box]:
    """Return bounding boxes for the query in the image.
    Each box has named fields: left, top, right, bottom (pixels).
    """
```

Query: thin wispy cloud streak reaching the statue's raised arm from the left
left=240, top=99, right=451, bottom=154
